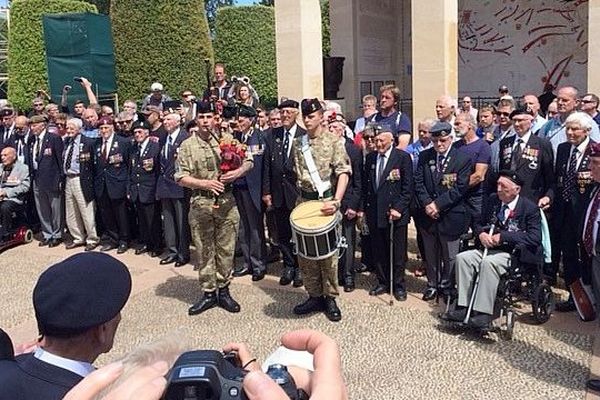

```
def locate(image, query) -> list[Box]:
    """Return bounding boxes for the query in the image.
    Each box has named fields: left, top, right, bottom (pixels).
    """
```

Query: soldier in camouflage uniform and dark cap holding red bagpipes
left=175, top=102, right=253, bottom=315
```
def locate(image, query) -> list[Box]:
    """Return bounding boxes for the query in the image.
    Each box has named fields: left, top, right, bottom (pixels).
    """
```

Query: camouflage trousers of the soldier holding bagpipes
left=189, top=193, right=240, bottom=292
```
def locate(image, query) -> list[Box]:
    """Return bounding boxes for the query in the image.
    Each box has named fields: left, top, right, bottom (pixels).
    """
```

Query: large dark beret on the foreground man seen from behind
left=33, top=252, right=131, bottom=337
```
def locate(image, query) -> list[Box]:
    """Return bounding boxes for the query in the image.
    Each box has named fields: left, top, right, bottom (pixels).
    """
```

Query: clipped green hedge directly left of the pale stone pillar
left=214, top=6, right=277, bottom=106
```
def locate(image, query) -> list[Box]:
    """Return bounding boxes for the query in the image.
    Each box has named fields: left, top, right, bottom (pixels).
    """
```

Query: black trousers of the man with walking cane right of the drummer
left=369, top=223, right=408, bottom=287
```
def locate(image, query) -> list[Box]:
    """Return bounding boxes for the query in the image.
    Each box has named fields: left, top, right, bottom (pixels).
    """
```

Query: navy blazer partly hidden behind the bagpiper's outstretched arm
left=234, top=129, right=265, bottom=210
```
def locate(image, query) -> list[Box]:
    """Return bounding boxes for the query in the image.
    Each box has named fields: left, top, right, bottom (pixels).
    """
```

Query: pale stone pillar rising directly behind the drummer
left=275, top=0, right=323, bottom=101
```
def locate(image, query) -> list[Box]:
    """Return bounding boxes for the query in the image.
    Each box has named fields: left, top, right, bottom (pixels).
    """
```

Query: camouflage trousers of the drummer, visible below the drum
left=298, top=251, right=340, bottom=297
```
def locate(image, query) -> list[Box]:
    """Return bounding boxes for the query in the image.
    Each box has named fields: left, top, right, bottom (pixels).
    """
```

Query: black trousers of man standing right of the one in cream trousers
left=97, top=188, right=131, bottom=245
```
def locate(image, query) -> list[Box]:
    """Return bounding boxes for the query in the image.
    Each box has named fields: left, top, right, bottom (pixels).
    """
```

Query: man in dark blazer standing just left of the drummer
left=262, top=99, right=306, bottom=287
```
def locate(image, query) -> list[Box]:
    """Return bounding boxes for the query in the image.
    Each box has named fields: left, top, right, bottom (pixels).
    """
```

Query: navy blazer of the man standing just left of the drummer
left=262, top=125, right=306, bottom=210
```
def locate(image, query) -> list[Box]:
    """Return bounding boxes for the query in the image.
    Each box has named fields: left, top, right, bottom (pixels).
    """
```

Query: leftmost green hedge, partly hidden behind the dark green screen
left=8, top=0, right=96, bottom=110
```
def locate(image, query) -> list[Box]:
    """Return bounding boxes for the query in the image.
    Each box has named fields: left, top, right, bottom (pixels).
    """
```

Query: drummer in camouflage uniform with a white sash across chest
left=292, top=99, right=352, bottom=321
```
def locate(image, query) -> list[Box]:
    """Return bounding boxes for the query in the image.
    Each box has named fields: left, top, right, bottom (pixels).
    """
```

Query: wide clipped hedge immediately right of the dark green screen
left=110, top=0, right=213, bottom=104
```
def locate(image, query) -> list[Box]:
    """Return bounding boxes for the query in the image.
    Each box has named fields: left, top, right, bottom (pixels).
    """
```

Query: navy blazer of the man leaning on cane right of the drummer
left=363, top=148, right=413, bottom=229
